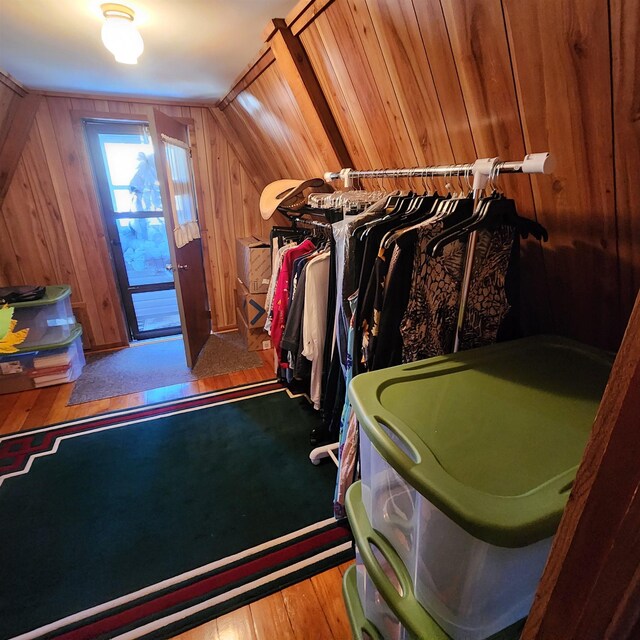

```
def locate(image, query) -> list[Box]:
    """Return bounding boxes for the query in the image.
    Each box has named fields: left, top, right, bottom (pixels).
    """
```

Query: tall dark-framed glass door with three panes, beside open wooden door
left=85, top=121, right=181, bottom=340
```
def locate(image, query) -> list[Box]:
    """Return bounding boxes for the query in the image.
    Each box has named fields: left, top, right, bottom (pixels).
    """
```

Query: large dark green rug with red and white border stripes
left=0, top=382, right=352, bottom=640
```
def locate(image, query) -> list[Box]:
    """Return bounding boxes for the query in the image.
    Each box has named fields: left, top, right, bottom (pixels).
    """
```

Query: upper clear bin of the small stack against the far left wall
left=10, top=285, right=76, bottom=349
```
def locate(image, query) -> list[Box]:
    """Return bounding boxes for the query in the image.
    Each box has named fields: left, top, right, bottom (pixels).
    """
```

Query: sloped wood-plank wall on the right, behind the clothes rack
left=218, top=0, right=640, bottom=348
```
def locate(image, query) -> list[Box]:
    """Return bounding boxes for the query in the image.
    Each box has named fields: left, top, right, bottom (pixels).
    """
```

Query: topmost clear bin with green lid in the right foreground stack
left=349, top=337, right=612, bottom=640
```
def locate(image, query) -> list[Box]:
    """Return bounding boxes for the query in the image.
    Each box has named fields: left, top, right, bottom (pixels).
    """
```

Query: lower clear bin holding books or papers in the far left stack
left=0, top=324, right=85, bottom=393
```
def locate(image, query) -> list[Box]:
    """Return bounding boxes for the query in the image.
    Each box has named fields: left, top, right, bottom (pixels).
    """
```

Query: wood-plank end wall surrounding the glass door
left=0, top=96, right=268, bottom=348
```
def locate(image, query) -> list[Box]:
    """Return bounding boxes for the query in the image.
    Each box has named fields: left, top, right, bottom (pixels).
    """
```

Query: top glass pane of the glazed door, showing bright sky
left=98, top=133, right=162, bottom=213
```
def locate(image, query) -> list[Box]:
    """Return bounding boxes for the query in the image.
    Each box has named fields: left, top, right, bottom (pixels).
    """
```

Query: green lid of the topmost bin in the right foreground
left=349, top=336, right=613, bottom=547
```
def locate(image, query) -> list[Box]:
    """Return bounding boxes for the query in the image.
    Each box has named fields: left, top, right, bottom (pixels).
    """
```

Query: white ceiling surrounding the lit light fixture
left=0, top=0, right=295, bottom=100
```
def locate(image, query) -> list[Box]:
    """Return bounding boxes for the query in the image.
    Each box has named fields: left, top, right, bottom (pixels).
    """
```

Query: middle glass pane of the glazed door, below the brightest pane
left=116, top=218, right=173, bottom=286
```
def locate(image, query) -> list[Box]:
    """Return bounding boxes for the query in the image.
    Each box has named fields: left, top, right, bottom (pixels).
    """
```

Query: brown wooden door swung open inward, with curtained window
left=152, top=109, right=211, bottom=368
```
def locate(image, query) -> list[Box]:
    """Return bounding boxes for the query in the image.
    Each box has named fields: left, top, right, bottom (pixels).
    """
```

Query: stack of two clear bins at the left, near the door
left=0, top=285, right=85, bottom=393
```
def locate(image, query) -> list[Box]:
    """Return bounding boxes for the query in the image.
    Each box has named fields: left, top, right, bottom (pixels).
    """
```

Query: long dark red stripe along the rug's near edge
left=56, top=525, right=351, bottom=640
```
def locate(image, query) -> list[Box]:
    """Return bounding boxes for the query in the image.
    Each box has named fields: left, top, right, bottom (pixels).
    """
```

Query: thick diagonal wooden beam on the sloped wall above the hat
left=270, top=19, right=353, bottom=168
